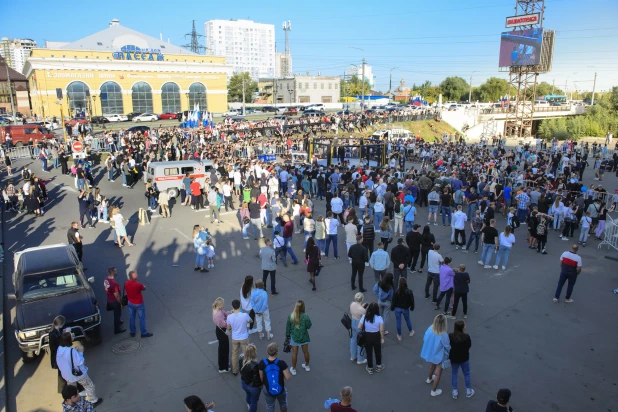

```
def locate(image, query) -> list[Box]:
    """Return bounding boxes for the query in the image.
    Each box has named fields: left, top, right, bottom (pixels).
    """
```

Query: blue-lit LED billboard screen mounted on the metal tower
left=498, top=28, right=543, bottom=67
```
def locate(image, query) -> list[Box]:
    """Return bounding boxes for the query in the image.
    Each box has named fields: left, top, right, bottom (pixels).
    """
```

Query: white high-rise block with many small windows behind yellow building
left=204, top=20, right=275, bottom=80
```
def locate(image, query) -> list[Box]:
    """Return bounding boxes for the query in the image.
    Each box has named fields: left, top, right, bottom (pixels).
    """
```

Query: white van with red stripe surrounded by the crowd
left=144, top=160, right=219, bottom=198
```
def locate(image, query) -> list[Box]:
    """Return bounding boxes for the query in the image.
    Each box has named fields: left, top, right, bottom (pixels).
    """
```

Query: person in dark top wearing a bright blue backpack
left=258, top=342, right=292, bottom=412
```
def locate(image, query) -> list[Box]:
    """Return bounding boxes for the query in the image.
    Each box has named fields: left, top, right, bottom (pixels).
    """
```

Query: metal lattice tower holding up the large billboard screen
left=504, top=0, right=555, bottom=138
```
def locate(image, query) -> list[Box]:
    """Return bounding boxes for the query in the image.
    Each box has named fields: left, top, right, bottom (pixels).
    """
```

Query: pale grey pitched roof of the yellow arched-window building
left=54, top=19, right=196, bottom=56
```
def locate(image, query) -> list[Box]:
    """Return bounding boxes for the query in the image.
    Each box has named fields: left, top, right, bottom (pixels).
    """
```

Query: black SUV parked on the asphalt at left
left=7, top=244, right=101, bottom=362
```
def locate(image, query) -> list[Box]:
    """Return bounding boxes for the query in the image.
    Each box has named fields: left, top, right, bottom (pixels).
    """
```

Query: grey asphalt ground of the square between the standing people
left=2, top=155, right=618, bottom=412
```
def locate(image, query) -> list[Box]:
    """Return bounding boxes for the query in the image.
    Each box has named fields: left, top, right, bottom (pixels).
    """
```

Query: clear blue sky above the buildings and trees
left=0, top=0, right=618, bottom=91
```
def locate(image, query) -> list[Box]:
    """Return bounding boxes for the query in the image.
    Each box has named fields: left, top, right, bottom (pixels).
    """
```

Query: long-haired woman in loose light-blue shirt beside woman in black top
left=421, top=314, right=451, bottom=396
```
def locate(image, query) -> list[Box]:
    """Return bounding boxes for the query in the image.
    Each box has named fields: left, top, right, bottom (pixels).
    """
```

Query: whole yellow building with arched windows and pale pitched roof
left=24, top=23, right=233, bottom=117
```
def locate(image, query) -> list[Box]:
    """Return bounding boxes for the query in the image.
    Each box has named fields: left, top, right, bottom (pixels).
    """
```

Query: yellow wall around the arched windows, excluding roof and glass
left=25, top=49, right=231, bottom=116
